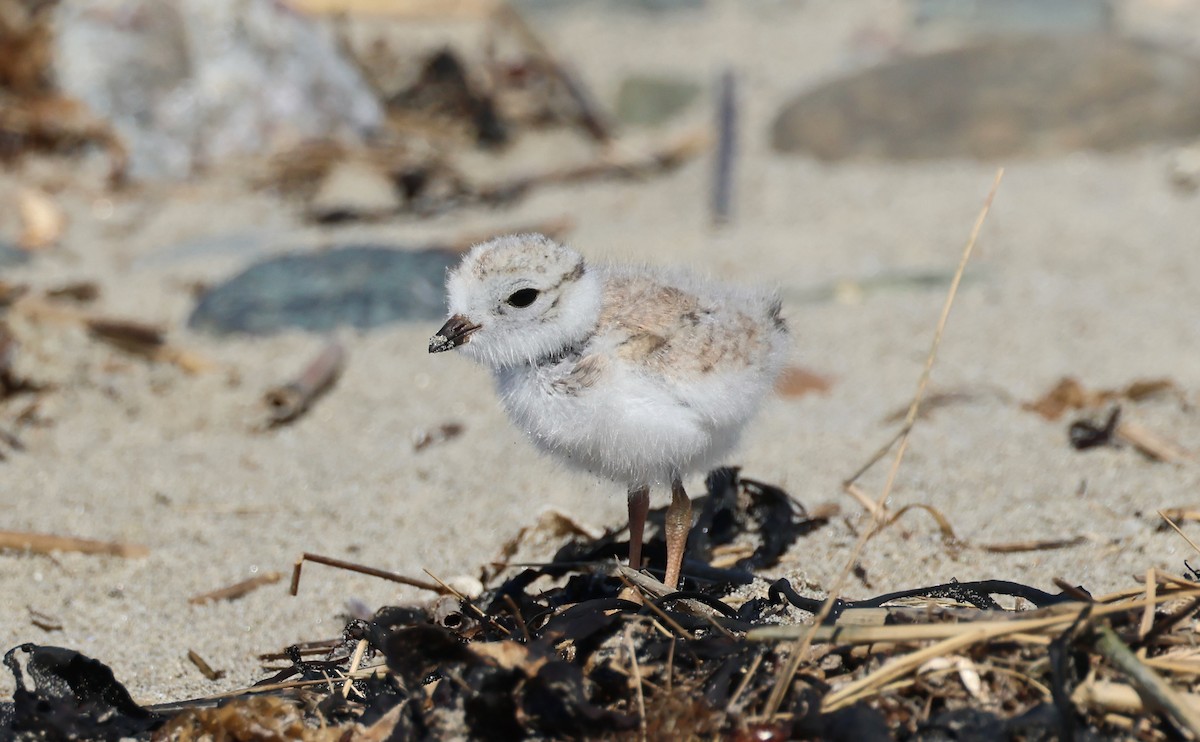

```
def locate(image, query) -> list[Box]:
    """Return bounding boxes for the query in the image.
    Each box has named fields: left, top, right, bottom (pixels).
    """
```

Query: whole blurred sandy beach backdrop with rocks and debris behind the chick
left=0, top=0, right=1200, bottom=700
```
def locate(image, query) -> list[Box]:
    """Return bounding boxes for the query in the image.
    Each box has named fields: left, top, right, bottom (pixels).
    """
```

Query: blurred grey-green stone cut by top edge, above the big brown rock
left=913, top=0, right=1112, bottom=35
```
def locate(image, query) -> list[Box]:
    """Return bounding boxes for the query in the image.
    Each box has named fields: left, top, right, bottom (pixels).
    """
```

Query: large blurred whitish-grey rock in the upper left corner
left=55, top=0, right=383, bottom=178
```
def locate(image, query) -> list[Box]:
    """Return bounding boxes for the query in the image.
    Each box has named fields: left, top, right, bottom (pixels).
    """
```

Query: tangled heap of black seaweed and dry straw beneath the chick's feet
left=7, top=469, right=1200, bottom=740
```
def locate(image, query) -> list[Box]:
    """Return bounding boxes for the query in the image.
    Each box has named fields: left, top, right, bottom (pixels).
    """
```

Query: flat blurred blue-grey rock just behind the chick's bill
left=187, top=246, right=460, bottom=335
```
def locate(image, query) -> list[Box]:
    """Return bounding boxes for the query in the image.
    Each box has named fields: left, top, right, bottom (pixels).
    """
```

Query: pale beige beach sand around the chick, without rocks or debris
left=0, top=1, right=1200, bottom=702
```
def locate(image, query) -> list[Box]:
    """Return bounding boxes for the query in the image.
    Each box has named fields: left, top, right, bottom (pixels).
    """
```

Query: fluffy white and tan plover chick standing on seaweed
left=430, top=234, right=788, bottom=588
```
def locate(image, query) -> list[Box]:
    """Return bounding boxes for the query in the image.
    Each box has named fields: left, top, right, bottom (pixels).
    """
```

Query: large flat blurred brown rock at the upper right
left=772, top=36, right=1200, bottom=160
